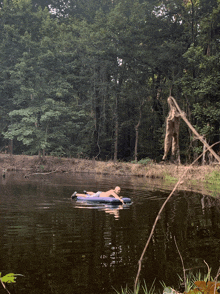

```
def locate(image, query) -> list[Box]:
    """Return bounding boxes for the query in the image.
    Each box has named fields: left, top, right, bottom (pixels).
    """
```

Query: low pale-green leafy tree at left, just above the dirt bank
left=4, top=99, right=85, bottom=155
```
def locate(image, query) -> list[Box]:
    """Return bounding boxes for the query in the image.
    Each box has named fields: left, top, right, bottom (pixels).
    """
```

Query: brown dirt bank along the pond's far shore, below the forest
left=0, top=154, right=220, bottom=194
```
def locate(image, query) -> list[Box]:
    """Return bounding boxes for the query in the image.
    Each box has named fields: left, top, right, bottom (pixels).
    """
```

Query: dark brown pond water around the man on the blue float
left=0, top=173, right=220, bottom=294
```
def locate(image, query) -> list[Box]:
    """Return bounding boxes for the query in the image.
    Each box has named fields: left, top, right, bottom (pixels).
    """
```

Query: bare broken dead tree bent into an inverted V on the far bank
left=163, top=96, right=220, bottom=163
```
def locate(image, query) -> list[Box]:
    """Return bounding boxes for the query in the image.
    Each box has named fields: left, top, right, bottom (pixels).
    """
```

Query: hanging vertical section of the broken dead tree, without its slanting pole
left=163, top=96, right=180, bottom=163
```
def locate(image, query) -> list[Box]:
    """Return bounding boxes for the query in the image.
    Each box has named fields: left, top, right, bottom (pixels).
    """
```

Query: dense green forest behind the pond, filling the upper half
left=0, top=0, right=220, bottom=163
